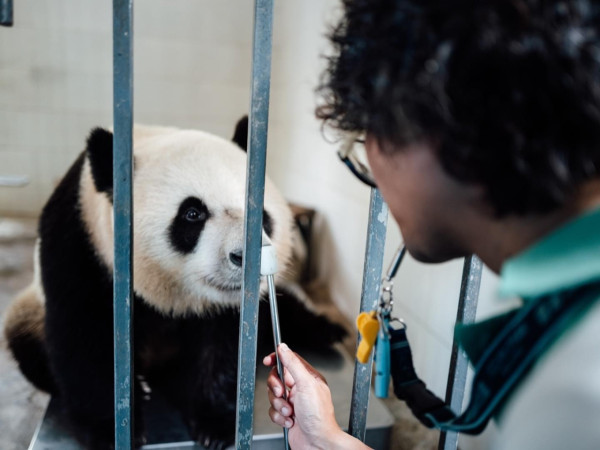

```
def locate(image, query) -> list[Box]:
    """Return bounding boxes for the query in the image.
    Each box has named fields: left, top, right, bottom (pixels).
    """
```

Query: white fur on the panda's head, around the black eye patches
left=80, top=126, right=292, bottom=315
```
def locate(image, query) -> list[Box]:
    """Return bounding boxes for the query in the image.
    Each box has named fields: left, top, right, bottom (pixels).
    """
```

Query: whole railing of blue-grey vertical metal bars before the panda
left=105, top=0, right=481, bottom=450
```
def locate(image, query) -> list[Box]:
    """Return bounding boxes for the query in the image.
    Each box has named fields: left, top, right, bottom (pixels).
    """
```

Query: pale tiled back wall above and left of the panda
left=0, top=0, right=252, bottom=215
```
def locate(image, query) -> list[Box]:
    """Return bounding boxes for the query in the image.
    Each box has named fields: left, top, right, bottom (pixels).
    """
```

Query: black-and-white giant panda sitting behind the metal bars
left=5, top=119, right=345, bottom=449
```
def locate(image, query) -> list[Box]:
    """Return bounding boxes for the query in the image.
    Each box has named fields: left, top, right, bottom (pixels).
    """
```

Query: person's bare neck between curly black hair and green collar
left=474, top=180, right=600, bottom=273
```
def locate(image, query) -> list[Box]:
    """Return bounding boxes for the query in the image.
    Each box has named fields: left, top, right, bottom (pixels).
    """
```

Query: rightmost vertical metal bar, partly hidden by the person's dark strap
left=438, top=256, right=482, bottom=450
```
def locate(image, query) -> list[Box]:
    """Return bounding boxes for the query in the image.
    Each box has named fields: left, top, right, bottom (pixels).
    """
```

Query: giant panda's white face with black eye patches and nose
left=81, top=126, right=292, bottom=315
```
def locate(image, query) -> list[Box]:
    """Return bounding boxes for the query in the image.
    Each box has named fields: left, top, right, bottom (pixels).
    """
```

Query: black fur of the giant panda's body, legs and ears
left=5, top=119, right=345, bottom=449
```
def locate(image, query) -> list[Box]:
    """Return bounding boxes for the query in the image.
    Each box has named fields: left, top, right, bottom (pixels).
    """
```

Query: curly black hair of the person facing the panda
left=317, top=0, right=600, bottom=216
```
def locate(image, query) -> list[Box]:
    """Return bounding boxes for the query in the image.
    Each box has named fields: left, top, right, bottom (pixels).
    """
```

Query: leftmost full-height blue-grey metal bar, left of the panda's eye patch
left=113, top=0, right=133, bottom=450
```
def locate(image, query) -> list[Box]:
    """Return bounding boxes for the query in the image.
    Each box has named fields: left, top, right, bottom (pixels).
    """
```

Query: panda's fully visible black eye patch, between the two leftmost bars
left=169, top=197, right=210, bottom=254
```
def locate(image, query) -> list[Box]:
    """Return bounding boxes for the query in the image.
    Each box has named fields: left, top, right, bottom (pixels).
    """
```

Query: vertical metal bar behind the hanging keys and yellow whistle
left=348, top=189, right=388, bottom=441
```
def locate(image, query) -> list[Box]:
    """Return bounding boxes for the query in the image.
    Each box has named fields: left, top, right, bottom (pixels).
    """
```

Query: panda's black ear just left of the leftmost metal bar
left=86, top=128, right=113, bottom=195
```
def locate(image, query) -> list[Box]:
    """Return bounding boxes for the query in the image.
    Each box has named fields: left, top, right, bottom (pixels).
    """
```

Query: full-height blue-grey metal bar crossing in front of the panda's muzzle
left=235, top=0, right=273, bottom=450
